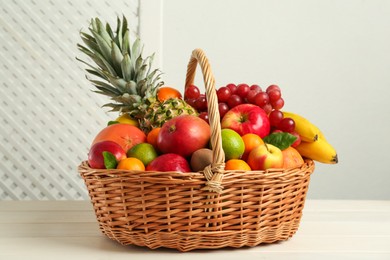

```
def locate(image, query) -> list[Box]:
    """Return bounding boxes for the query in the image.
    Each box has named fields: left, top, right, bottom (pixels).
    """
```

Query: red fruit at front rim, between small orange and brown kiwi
left=146, top=153, right=191, bottom=172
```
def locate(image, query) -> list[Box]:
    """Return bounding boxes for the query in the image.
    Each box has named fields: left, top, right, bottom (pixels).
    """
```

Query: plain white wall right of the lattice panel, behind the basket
left=162, top=0, right=390, bottom=199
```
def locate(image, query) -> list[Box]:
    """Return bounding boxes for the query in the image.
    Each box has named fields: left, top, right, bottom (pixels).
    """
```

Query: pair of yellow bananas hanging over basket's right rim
left=283, top=111, right=338, bottom=164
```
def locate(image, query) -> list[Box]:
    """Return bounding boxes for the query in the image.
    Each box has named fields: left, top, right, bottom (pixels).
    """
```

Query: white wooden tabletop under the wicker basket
left=0, top=200, right=390, bottom=260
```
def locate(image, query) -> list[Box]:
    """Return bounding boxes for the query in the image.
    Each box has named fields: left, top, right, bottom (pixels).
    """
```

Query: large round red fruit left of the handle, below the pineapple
left=157, top=115, right=211, bottom=157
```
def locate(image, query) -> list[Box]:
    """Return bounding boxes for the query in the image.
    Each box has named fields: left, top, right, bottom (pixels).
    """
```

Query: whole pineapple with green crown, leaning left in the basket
left=77, top=17, right=197, bottom=133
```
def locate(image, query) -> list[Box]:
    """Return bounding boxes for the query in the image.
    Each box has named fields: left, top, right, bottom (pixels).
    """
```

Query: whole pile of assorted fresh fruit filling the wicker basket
left=78, top=18, right=338, bottom=172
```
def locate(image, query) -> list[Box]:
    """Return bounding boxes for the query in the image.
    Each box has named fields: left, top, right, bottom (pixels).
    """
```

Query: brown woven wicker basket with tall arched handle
left=78, top=49, right=314, bottom=251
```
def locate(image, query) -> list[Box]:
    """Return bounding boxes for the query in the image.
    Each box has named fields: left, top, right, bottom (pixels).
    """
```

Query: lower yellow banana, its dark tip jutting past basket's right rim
left=296, top=137, right=338, bottom=164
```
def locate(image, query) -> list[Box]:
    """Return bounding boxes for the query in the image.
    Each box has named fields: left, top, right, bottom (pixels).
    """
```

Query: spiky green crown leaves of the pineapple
left=76, top=16, right=163, bottom=113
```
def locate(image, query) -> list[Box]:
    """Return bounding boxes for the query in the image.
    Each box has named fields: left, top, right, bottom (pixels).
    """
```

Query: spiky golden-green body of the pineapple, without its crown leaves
left=139, top=98, right=198, bottom=132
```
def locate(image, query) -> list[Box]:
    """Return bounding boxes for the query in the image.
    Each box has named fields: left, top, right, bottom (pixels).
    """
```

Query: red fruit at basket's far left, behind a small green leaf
left=88, top=141, right=126, bottom=169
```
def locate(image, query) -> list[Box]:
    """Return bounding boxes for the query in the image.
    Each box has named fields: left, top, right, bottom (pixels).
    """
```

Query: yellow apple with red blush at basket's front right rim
left=247, top=143, right=283, bottom=170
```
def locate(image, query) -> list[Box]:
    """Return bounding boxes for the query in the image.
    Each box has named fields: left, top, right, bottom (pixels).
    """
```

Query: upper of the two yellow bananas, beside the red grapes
left=283, top=111, right=321, bottom=142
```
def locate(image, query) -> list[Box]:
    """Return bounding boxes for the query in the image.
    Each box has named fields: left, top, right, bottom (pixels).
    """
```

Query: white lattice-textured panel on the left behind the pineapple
left=0, top=0, right=139, bottom=200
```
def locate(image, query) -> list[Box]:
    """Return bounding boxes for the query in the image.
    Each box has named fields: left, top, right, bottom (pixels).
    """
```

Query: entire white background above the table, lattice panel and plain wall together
left=0, top=0, right=390, bottom=199
